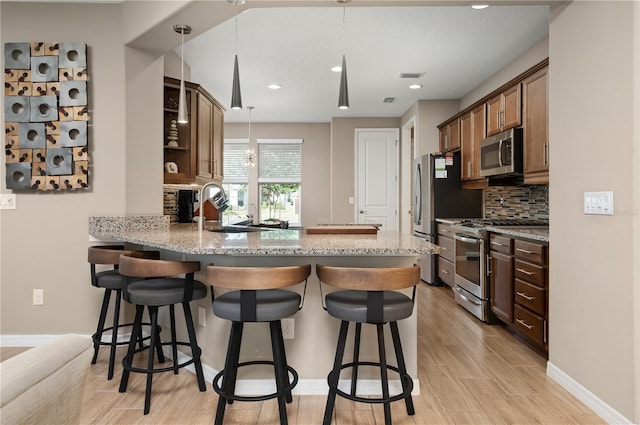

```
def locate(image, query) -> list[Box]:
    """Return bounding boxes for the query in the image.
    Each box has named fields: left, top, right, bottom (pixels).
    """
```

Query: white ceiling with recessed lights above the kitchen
left=180, top=3, right=549, bottom=122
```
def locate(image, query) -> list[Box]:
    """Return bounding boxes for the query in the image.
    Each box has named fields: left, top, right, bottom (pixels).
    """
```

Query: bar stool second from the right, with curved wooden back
left=207, top=265, right=311, bottom=425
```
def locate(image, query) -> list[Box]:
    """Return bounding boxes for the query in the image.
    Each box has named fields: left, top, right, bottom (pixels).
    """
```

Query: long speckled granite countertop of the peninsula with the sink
left=89, top=216, right=440, bottom=256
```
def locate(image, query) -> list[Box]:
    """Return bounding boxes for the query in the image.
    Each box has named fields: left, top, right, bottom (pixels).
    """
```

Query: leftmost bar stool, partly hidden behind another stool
left=88, top=245, right=160, bottom=380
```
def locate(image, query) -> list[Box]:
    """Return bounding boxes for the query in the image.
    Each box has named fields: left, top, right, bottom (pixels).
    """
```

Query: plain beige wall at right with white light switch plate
left=549, top=1, right=640, bottom=423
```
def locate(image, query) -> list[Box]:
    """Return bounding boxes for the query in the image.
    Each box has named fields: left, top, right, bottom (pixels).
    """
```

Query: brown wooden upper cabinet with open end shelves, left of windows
left=164, top=77, right=224, bottom=184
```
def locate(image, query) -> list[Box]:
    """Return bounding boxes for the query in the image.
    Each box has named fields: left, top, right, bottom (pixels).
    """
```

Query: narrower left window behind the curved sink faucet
left=222, top=139, right=249, bottom=225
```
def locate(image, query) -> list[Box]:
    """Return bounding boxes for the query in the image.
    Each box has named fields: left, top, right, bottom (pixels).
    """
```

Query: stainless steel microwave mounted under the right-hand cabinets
left=480, top=128, right=522, bottom=177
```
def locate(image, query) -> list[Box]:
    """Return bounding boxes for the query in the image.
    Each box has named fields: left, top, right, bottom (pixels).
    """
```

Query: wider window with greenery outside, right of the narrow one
left=258, top=139, right=302, bottom=225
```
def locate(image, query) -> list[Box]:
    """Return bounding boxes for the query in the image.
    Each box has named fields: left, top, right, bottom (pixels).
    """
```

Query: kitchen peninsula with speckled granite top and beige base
left=89, top=216, right=439, bottom=394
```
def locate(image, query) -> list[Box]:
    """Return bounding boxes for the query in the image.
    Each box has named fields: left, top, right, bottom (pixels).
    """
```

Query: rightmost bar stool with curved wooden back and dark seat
left=316, top=265, right=420, bottom=425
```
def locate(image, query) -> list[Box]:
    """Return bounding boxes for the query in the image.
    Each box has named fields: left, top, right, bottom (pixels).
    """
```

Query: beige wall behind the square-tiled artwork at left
left=0, top=2, right=127, bottom=335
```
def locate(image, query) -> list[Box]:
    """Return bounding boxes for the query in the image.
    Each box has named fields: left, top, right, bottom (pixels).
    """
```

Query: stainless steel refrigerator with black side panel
left=413, top=152, right=483, bottom=285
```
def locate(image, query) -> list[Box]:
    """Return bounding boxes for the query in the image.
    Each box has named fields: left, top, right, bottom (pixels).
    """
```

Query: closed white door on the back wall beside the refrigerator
left=356, top=128, right=398, bottom=231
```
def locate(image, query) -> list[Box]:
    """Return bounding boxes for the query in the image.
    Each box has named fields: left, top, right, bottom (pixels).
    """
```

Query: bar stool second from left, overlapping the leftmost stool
left=119, top=252, right=207, bottom=415
